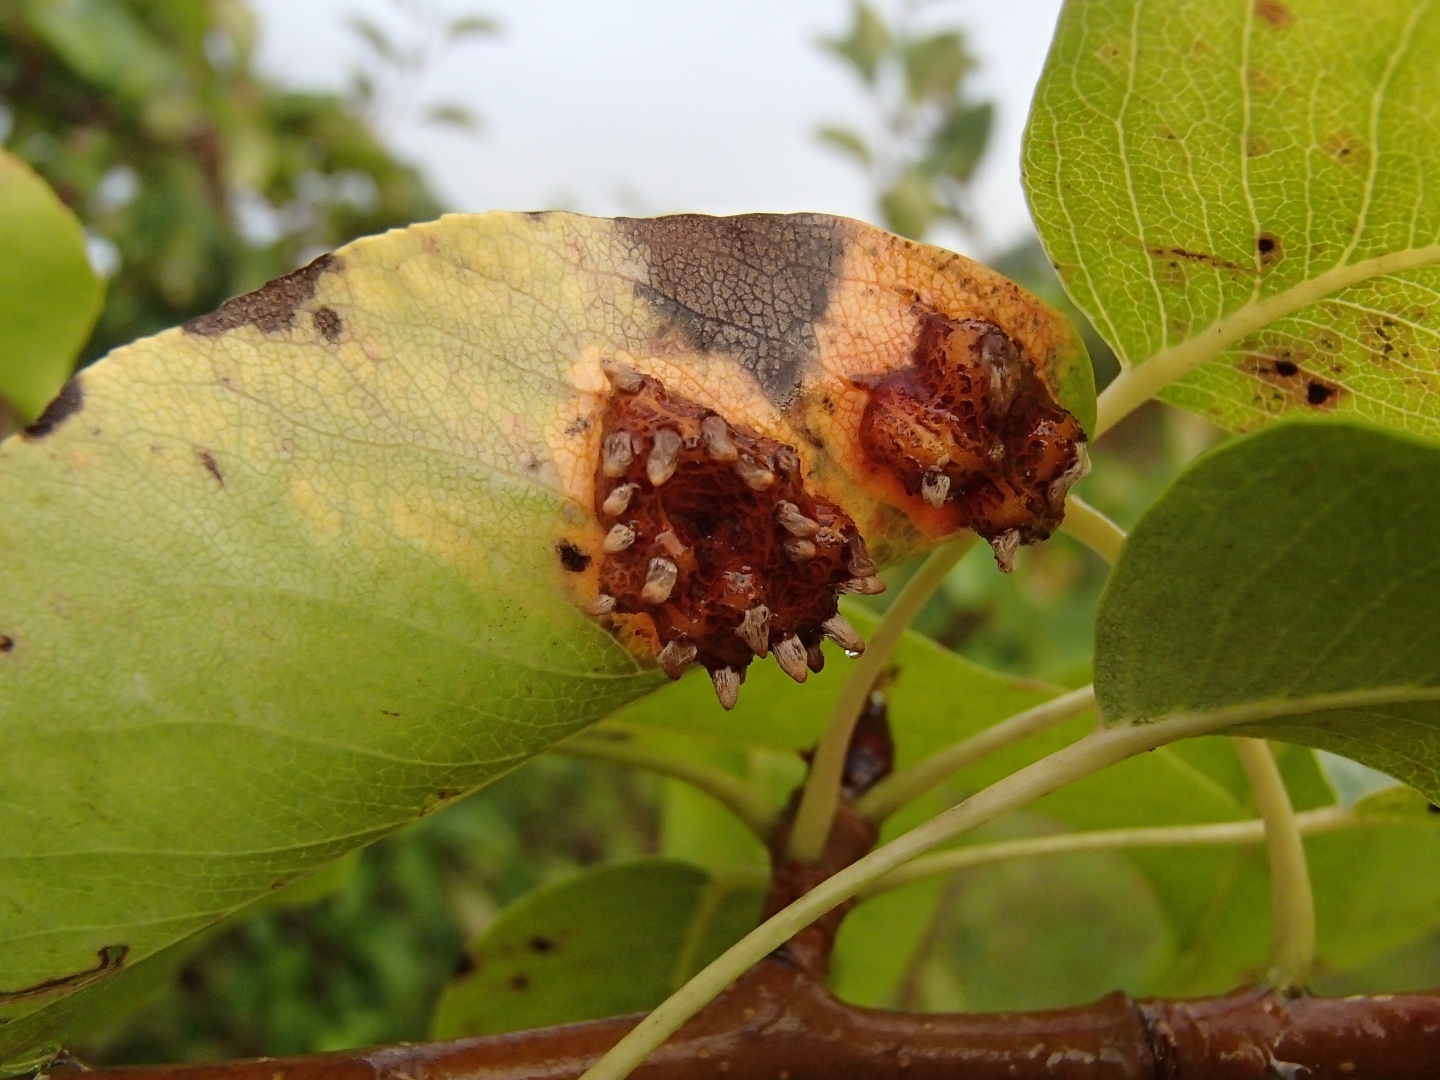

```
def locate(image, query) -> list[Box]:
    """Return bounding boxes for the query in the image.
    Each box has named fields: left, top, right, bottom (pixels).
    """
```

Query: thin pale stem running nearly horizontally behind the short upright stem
left=860, top=806, right=1353, bottom=900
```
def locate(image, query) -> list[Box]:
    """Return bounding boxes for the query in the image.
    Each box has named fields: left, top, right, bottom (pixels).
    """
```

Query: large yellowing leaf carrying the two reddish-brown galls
left=0, top=213, right=1093, bottom=1054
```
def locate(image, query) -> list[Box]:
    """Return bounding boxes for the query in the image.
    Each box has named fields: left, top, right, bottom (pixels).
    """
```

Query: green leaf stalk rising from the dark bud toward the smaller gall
left=788, top=533, right=976, bottom=863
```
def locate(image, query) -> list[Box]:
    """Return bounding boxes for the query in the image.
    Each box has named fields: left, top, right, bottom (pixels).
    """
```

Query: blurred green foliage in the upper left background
left=0, top=0, right=455, bottom=361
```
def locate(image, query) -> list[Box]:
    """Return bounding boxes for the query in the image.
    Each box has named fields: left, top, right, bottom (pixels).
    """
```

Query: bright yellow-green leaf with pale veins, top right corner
left=1024, top=0, right=1440, bottom=436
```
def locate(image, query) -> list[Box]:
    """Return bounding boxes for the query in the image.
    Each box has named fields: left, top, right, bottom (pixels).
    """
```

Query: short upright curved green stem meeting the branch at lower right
left=1231, top=737, right=1315, bottom=998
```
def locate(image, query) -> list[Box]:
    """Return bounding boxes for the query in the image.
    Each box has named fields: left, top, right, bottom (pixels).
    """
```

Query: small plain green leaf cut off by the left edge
left=0, top=150, right=105, bottom=423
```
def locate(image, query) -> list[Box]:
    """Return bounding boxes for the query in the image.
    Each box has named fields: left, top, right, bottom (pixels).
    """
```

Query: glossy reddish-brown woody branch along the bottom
left=75, top=959, right=1440, bottom=1080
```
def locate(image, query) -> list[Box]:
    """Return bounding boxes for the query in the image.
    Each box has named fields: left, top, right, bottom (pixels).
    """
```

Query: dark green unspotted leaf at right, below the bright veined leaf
left=1096, top=422, right=1440, bottom=799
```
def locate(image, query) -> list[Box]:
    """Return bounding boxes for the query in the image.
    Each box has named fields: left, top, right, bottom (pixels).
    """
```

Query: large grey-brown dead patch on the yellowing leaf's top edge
left=615, top=213, right=850, bottom=409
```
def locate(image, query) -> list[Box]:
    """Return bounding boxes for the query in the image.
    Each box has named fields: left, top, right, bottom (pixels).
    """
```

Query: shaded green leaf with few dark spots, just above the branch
left=431, top=860, right=765, bottom=1038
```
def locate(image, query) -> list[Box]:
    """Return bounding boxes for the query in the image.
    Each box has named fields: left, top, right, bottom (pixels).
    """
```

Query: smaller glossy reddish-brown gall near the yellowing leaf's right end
left=860, top=314, right=1090, bottom=570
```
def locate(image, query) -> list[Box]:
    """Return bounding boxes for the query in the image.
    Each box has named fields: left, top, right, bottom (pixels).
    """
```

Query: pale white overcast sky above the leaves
left=252, top=0, right=1060, bottom=257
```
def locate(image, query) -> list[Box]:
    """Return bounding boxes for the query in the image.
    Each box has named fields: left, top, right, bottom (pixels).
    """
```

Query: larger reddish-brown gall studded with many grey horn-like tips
left=590, top=366, right=884, bottom=708
